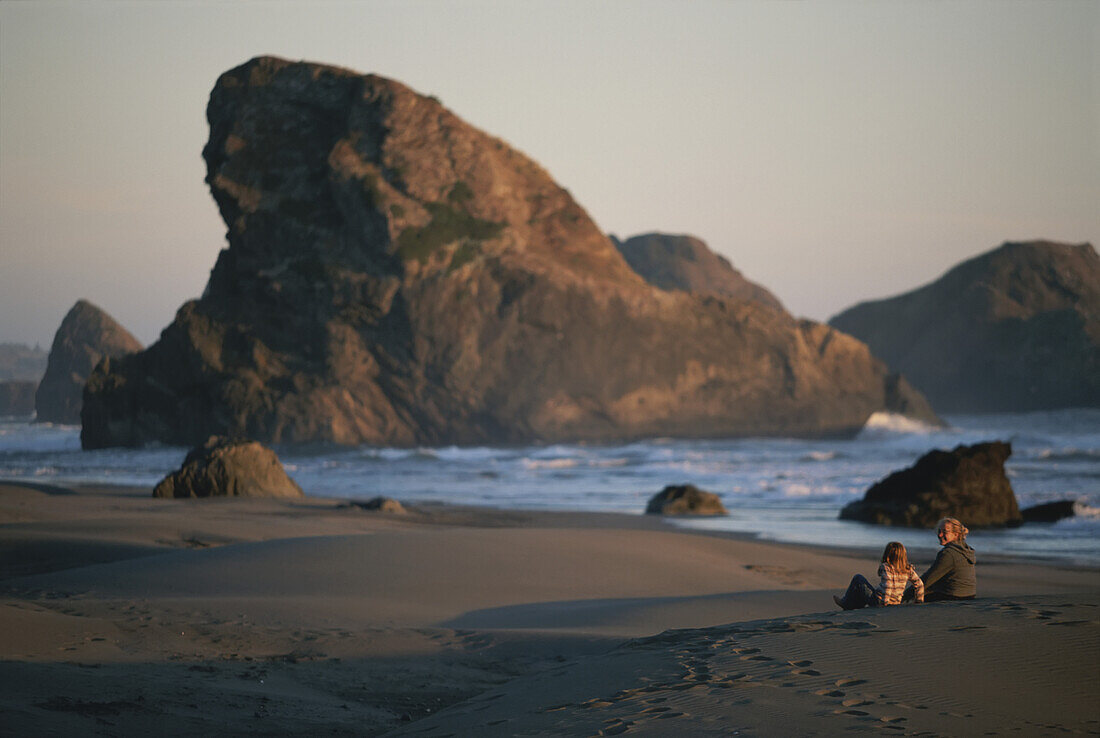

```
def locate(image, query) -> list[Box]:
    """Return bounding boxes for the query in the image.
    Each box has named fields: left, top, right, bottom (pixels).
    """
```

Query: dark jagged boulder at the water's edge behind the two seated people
left=840, top=441, right=1022, bottom=528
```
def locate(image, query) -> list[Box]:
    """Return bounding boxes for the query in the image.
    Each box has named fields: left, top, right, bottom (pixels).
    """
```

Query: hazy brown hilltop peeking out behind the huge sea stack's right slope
left=611, top=233, right=783, bottom=310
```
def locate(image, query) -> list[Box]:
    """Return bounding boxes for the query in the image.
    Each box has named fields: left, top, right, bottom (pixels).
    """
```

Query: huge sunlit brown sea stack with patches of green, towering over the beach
left=81, top=57, right=934, bottom=448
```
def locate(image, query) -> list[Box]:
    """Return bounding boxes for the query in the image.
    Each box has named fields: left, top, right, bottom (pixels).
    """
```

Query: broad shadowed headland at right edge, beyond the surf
left=829, top=241, right=1100, bottom=412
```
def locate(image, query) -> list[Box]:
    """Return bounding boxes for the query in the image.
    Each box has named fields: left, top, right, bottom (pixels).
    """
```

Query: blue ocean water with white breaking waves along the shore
left=0, top=409, right=1100, bottom=565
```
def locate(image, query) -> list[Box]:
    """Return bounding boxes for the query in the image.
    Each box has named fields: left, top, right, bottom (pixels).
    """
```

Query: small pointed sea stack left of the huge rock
left=34, top=300, right=142, bottom=423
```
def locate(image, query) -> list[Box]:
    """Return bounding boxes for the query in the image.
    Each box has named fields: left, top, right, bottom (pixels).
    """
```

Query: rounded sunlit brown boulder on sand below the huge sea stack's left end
left=153, top=436, right=304, bottom=498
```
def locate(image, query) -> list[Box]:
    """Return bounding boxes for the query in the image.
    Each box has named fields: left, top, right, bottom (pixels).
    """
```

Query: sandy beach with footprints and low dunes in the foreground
left=0, top=482, right=1100, bottom=736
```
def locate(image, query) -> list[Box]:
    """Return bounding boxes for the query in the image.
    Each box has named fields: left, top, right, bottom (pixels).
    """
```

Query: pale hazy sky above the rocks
left=0, top=0, right=1100, bottom=348
